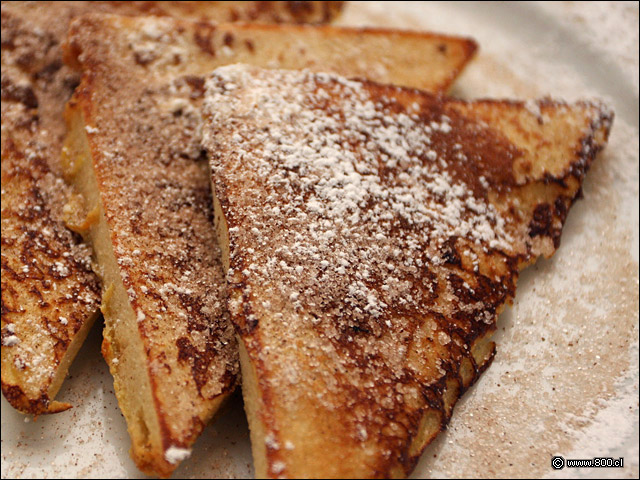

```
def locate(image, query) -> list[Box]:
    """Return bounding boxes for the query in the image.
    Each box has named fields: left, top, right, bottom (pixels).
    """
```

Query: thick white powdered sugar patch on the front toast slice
left=205, top=66, right=512, bottom=342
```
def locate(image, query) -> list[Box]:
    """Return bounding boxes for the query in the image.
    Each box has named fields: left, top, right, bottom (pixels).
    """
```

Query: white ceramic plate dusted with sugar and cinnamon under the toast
left=2, top=2, right=638, bottom=478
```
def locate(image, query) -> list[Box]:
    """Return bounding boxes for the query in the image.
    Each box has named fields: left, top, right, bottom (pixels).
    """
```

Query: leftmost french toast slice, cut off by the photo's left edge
left=2, top=2, right=342, bottom=415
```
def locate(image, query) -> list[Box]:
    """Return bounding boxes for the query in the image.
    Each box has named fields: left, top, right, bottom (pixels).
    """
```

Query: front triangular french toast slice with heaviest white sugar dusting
left=203, top=65, right=612, bottom=478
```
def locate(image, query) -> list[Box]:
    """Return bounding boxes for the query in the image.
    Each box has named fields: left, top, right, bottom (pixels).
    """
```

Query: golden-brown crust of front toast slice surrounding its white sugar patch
left=205, top=69, right=613, bottom=478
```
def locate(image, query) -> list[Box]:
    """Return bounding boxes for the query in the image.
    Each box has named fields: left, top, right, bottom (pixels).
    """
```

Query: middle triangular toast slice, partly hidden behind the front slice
left=65, top=16, right=475, bottom=475
